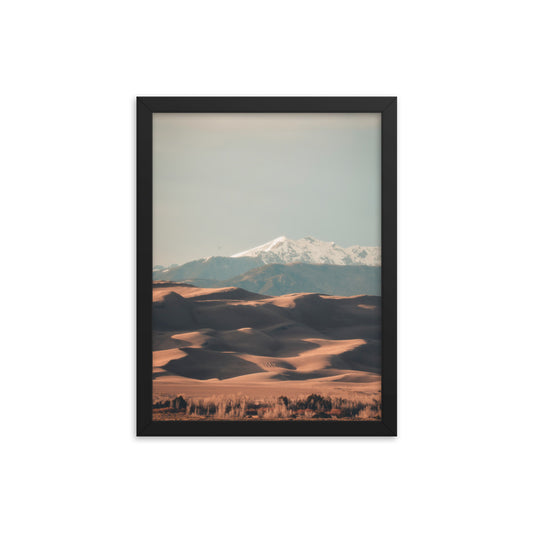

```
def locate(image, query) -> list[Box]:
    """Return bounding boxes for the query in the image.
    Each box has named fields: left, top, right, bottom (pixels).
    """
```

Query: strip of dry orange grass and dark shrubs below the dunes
left=152, top=394, right=381, bottom=421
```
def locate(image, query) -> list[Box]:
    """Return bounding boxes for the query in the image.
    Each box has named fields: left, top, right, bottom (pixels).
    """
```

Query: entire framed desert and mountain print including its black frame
left=137, top=97, right=397, bottom=436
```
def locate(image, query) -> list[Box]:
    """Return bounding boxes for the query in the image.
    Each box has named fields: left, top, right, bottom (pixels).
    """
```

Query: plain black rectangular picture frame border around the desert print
left=137, top=96, right=397, bottom=436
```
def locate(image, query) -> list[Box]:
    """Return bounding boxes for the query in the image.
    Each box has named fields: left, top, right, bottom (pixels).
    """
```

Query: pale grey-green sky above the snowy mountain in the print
left=153, top=113, right=381, bottom=266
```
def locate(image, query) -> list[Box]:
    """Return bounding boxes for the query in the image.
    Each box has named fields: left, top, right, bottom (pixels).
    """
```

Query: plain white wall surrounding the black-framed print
left=0, top=0, right=533, bottom=533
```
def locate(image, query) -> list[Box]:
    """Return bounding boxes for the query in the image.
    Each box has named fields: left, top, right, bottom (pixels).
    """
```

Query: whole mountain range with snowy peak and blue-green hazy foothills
left=153, top=237, right=381, bottom=296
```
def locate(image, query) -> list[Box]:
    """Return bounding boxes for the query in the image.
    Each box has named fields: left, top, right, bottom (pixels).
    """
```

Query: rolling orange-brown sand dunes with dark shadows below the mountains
left=153, top=282, right=381, bottom=418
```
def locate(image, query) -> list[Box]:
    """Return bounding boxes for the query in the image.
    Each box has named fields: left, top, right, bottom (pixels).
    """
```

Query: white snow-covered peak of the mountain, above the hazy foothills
left=231, top=236, right=381, bottom=266
